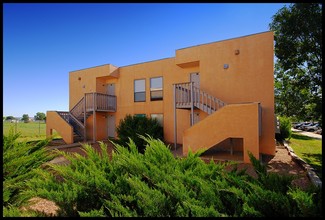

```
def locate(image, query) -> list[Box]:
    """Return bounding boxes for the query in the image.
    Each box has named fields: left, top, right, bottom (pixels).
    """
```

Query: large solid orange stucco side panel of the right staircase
left=183, top=103, right=259, bottom=163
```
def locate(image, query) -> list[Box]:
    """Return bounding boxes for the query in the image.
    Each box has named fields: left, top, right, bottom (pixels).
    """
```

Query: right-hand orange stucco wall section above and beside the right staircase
left=176, top=32, right=275, bottom=155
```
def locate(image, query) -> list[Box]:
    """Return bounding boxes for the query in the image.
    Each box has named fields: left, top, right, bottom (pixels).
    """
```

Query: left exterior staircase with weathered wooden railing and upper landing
left=57, top=93, right=116, bottom=142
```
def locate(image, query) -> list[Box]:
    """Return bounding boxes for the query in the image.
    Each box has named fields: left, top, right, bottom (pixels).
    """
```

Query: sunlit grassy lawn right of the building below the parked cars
left=289, top=132, right=322, bottom=180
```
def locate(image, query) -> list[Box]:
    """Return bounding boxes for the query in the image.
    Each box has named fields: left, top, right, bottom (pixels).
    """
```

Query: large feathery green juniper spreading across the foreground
left=20, top=136, right=321, bottom=217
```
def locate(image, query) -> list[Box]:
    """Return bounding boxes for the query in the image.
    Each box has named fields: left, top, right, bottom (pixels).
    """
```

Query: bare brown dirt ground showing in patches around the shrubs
left=23, top=139, right=311, bottom=216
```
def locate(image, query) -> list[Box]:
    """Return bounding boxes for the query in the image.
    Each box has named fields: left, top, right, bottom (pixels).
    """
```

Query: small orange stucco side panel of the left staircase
left=46, top=111, right=74, bottom=144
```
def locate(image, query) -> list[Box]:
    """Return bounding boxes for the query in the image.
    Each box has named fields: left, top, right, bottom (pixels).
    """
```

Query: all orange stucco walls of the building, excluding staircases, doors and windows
left=48, top=32, right=275, bottom=158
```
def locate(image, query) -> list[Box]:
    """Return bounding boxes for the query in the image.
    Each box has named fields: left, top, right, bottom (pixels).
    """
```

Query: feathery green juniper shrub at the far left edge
left=3, top=129, right=55, bottom=216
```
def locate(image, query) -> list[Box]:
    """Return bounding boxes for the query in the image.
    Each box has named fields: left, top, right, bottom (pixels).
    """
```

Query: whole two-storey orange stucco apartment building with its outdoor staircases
left=46, top=32, right=275, bottom=162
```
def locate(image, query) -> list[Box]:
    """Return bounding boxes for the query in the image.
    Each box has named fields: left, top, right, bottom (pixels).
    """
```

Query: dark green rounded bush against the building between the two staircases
left=116, top=115, right=163, bottom=153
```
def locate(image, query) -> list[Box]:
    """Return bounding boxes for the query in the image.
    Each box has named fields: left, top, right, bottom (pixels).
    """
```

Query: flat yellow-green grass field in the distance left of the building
left=3, top=121, right=60, bottom=141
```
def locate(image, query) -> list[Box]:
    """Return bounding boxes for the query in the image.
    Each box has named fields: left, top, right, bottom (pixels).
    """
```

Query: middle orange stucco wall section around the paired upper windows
left=116, top=58, right=199, bottom=143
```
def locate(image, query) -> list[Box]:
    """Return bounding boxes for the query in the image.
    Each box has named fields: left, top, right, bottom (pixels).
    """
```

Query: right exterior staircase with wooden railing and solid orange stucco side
left=174, top=82, right=261, bottom=163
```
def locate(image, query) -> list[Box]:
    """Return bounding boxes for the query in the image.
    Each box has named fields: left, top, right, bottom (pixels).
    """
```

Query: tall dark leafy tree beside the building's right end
left=270, top=3, right=322, bottom=126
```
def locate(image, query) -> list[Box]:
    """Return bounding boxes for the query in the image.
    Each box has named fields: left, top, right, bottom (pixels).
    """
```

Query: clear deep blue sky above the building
left=3, top=3, right=287, bottom=117
